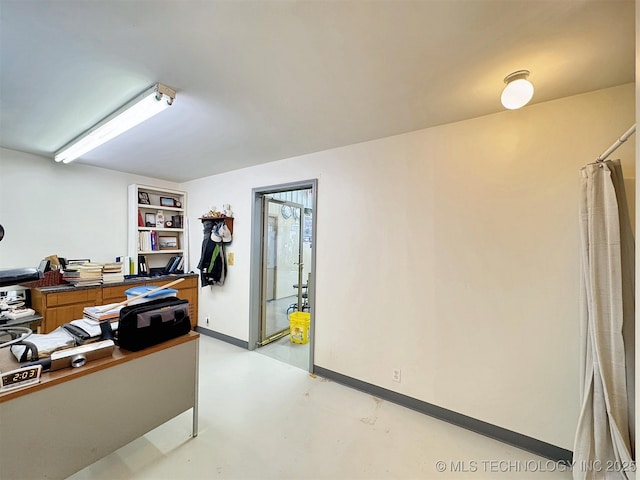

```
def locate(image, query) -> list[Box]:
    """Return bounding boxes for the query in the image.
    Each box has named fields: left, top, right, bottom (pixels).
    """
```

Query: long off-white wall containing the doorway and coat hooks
left=182, top=84, right=635, bottom=449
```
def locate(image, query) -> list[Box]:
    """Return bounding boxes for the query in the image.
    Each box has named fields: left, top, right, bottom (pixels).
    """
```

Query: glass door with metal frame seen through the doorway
left=259, top=196, right=306, bottom=345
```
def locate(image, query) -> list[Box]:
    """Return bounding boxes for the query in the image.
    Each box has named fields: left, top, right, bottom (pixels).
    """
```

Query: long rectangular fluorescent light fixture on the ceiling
left=53, top=83, right=176, bottom=163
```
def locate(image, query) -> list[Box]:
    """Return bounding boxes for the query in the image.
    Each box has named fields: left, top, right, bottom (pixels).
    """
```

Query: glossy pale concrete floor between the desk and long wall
left=70, top=336, right=571, bottom=480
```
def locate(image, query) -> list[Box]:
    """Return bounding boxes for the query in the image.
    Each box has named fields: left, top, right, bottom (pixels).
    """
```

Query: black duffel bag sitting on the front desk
left=117, top=297, right=191, bottom=352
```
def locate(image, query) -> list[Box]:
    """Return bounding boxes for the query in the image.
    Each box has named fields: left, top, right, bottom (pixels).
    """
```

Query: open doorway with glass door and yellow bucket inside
left=249, top=180, right=317, bottom=371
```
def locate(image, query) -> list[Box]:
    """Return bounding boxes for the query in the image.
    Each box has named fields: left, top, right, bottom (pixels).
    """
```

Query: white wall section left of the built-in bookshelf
left=0, top=149, right=177, bottom=268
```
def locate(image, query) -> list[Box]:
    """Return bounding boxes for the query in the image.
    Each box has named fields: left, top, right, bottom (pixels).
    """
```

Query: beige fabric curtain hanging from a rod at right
left=573, top=160, right=635, bottom=480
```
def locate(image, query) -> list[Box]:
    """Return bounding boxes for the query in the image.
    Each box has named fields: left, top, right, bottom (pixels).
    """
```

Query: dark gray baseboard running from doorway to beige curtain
left=313, top=365, right=573, bottom=464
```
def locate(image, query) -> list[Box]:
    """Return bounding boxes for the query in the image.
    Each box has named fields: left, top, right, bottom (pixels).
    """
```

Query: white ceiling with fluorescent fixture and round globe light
left=0, top=0, right=635, bottom=182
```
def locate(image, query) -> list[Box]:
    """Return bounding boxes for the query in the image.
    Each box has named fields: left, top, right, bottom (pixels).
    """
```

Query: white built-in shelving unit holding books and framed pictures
left=128, top=184, right=189, bottom=274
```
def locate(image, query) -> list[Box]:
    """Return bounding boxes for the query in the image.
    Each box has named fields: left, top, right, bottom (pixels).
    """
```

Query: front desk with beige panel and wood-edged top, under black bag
left=0, top=332, right=200, bottom=479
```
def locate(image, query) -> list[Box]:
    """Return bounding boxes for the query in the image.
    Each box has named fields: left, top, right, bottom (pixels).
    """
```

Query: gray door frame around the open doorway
left=248, top=178, right=318, bottom=373
